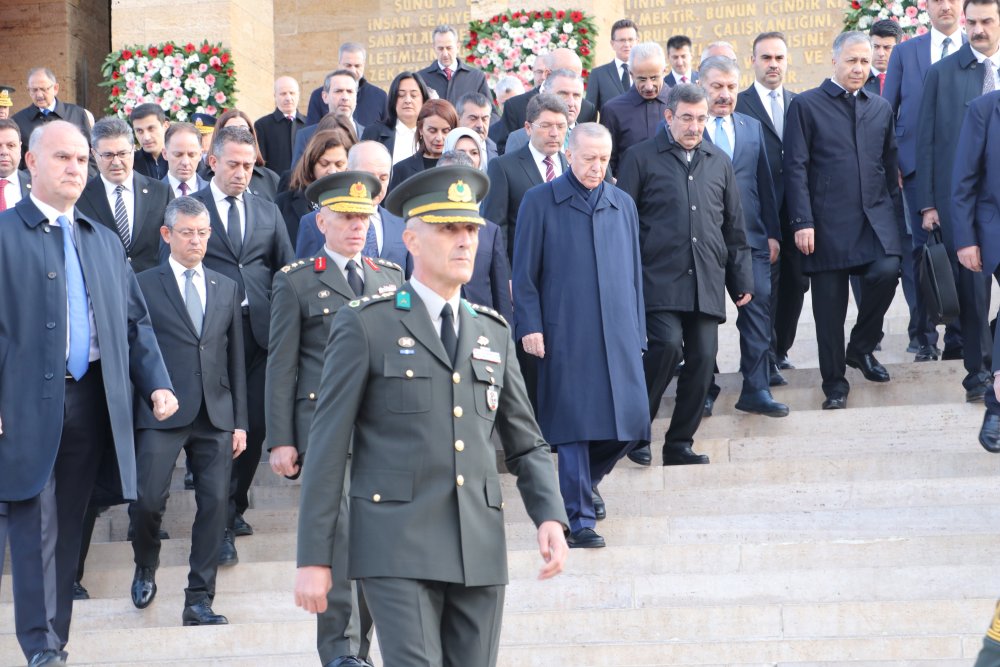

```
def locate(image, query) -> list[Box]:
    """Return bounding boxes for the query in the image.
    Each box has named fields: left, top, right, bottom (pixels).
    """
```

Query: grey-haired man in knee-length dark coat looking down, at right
left=785, top=32, right=902, bottom=410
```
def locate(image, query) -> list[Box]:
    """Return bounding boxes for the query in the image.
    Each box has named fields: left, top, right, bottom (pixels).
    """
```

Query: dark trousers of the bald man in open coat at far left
left=7, top=362, right=114, bottom=658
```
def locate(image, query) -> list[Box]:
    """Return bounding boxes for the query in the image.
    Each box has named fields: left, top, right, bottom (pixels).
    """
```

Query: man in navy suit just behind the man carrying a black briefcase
left=882, top=0, right=965, bottom=360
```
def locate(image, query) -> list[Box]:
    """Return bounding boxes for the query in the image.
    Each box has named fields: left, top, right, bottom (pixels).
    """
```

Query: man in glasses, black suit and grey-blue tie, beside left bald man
left=132, top=197, right=247, bottom=625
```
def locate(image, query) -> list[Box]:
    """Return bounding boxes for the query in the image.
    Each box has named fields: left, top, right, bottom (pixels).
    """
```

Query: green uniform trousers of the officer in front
left=361, top=577, right=504, bottom=667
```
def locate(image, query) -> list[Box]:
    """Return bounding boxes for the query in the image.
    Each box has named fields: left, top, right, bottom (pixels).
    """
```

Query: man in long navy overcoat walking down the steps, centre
left=513, top=123, right=649, bottom=548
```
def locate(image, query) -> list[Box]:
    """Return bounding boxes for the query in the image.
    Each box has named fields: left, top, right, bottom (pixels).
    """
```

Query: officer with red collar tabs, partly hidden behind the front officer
left=265, top=171, right=403, bottom=667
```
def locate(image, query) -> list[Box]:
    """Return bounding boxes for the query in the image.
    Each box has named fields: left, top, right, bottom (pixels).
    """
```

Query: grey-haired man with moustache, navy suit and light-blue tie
left=698, top=56, right=788, bottom=417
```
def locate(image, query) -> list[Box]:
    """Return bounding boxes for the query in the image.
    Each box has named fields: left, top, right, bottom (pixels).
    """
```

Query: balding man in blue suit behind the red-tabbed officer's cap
left=295, top=141, right=413, bottom=278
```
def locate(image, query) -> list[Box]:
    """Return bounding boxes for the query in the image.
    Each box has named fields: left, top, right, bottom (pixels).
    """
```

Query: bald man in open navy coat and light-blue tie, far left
left=0, top=121, right=178, bottom=667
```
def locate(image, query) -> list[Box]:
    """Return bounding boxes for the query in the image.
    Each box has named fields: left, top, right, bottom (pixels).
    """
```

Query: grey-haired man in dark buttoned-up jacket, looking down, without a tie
left=601, top=42, right=670, bottom=173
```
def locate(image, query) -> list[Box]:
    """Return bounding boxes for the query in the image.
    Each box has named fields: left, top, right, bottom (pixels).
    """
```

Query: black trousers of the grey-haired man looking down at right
left=810, top=254, right=899, bottom=396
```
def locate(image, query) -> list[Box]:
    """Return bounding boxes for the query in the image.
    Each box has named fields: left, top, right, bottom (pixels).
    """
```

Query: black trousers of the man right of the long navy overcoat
left=642, top=310, right=719, bottom=447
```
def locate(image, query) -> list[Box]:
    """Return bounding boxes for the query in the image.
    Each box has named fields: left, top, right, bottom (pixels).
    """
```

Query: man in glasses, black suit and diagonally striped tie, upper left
left=77, top=116, right=174, bottom=272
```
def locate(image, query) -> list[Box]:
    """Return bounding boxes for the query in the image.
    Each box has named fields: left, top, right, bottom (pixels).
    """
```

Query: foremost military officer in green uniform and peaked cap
left=295, top=166, right=567, bottom=667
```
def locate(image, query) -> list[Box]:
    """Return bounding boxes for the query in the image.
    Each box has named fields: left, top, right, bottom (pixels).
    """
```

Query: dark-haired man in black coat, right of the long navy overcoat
left=618, top=83, right=754, bottom=465
